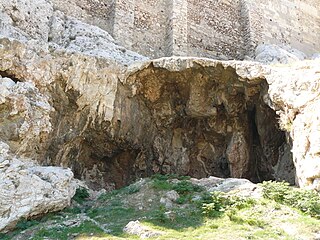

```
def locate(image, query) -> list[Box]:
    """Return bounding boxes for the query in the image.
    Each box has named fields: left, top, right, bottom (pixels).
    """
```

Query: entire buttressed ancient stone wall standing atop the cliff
left=50, top=0, right=320, bottom=59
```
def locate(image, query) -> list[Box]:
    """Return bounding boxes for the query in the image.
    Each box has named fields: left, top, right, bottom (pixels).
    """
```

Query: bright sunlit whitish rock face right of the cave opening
left=266, top=60, right=320, bottom=190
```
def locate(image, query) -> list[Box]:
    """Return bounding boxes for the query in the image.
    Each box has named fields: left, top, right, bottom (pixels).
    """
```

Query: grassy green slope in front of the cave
left=0, top=179, right=320, bottom=240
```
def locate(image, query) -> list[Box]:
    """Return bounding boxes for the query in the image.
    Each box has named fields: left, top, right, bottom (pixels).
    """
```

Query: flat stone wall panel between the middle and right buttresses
left=187, top=0, right=245, bottom=59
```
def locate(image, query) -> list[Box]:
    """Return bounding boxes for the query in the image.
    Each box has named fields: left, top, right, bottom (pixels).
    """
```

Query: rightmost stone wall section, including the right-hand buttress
left=246, top=0, right=320, bottom=55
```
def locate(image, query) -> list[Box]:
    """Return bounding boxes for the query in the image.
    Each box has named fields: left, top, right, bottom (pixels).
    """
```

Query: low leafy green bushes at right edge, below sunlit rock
left=261, top=181, right=320, bottom=219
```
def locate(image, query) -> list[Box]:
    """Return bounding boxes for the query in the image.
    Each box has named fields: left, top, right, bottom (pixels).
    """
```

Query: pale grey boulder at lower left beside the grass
left=0, top=142, right=76, bottom=231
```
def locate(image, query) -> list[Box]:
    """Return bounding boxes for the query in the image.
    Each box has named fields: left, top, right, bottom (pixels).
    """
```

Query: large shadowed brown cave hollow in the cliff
left=47, top=64, right=294, bottom=190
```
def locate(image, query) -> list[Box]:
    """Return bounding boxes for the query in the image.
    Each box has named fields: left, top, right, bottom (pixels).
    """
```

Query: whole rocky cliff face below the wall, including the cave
left=0, top=0, right=320, bottom=197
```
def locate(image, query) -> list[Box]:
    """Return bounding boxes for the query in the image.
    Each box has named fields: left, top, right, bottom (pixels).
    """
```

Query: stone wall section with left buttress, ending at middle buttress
left=112, top=0, right=168, bottom=58
